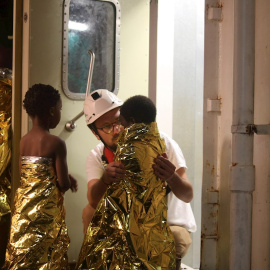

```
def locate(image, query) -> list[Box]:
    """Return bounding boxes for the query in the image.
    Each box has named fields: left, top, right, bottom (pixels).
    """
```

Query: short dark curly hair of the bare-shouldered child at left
left=23, top=83, right=60, bottom=117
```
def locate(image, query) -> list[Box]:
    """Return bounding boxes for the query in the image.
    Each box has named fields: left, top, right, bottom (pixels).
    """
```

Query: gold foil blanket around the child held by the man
left=77, top=123, right=175, bottom=270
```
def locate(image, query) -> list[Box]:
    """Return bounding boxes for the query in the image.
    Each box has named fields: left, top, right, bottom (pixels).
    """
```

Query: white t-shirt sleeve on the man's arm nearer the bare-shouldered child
left=86, top=143, right=104, bottom=182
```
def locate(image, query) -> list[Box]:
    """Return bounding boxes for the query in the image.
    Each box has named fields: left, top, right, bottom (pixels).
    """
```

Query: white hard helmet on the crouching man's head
left=83, top=89, right=123, bottom=125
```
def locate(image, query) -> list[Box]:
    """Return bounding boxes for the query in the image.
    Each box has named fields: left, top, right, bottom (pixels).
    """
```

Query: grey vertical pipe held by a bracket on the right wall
left=230, top=0, right=255, bottom=270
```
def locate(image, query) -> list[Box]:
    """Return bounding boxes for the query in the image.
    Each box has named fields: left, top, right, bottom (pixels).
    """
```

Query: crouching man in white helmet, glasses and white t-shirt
left=83, top=90, right=196, bottom=268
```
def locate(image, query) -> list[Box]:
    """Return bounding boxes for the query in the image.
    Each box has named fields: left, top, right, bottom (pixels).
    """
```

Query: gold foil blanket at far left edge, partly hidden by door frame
left=0, top=69, right=12, bottom=224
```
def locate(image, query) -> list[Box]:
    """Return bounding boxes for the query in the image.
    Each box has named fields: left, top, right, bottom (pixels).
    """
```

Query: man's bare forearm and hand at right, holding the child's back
left=153, top=153, right=193, bottom=203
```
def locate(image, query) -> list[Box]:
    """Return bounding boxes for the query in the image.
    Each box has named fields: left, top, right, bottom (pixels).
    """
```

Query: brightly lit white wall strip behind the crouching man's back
left=156, top=0, right=204, bottom=268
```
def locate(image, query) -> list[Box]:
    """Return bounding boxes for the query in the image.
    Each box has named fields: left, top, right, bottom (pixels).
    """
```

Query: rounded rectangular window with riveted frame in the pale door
left=62, top=0, right=121, bottom=99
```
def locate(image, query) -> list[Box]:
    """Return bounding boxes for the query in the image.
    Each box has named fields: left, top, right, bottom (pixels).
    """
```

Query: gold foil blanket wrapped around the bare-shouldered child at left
left=4, top=157, right=69, bottom=270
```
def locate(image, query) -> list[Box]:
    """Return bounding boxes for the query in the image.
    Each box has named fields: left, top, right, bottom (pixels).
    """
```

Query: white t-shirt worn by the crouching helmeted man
left=86, top=132, right=197, bottom=232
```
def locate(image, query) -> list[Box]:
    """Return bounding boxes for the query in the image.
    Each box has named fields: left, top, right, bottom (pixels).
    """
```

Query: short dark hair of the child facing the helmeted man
left=120, top=95, right=157, bottom=124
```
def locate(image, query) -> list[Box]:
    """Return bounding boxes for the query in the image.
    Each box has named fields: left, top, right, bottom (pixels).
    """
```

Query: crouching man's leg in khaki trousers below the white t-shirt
left=170, top=226, right=192, bottom=270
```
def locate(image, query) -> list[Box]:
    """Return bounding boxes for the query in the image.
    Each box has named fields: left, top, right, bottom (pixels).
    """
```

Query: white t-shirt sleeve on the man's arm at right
left=160, top=132, right=187, bottom=170
